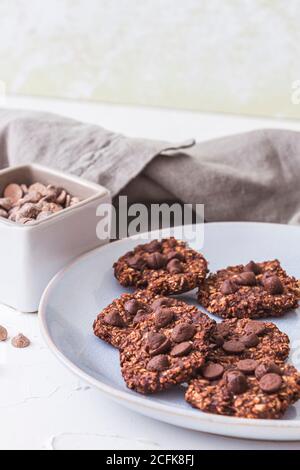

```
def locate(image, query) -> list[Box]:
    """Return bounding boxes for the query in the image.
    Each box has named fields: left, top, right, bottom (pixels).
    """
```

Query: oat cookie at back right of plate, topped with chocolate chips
left=198, top=260, right=300, bottom=318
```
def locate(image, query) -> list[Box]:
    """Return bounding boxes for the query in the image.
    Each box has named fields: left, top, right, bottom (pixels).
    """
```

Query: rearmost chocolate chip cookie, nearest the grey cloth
left=114, top=238, right=208, bottom=295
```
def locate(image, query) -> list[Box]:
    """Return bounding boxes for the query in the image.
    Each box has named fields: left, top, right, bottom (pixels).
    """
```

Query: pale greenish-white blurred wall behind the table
left=0, top=0, right=300, bottom=118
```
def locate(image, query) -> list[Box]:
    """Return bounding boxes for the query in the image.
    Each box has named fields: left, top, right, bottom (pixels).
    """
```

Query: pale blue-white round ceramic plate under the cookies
left=39, top=223, right=300, bottom=440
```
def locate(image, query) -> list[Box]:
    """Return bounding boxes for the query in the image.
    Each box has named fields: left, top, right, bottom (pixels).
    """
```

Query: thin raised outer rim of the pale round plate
left=38, top=222, right=300, bottom=441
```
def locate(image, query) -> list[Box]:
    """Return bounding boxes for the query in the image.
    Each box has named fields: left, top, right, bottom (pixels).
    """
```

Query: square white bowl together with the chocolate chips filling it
left=0, top=164, right=111, bottom=312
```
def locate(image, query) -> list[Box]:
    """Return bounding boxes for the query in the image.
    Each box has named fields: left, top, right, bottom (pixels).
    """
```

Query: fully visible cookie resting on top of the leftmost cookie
left=120, top=307, right=215, bottom=394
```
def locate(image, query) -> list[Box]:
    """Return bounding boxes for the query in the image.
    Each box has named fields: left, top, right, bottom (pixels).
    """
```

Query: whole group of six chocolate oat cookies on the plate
left=94, top=238, right=300, bottom=419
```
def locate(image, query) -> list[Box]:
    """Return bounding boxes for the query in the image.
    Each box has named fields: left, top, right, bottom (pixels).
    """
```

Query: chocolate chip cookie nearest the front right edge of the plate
left=185, top=359, right=300, bottom=419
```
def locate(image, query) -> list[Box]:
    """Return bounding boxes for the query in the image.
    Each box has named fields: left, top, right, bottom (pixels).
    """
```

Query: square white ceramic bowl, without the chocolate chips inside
left=0, top=165, right=111, bottom=312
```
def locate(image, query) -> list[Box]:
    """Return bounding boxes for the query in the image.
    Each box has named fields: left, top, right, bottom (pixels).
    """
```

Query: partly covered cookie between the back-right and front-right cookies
left=209, top=318, right=290, bottom=367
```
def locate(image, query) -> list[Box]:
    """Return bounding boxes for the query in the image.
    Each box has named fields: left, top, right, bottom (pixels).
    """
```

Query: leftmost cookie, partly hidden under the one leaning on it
left=94, top=290, right=202, bottom=348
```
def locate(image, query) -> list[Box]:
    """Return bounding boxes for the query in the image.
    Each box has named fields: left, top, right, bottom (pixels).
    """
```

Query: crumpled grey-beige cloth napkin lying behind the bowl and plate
left=0, top=110, right=300, bottom=228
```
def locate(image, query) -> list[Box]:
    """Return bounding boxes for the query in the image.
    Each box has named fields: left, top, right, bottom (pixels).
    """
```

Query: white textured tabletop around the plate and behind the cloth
left=0, top=94, right=300, bottom=450
